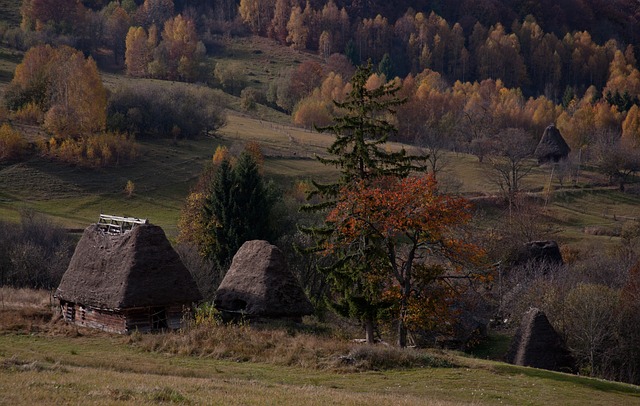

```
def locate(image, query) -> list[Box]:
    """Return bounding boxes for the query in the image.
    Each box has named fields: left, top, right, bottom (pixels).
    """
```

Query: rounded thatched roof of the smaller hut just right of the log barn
left=215, top=240, right=313, bottom=317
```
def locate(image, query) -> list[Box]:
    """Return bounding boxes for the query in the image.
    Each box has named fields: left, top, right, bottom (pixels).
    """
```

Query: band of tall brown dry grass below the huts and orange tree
left=128, top=325, right=453, bottom=372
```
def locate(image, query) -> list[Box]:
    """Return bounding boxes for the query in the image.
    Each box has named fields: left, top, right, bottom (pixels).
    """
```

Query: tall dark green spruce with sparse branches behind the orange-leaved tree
left=303, top=63, right=425, bottom=343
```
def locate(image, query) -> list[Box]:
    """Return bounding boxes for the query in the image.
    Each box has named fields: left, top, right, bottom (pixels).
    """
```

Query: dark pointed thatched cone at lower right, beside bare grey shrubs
left=506, top=308, right=575, bottom=372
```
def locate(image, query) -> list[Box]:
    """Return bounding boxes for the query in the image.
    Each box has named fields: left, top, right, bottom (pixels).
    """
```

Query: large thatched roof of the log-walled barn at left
left=56, top=224, right=202, bottom=309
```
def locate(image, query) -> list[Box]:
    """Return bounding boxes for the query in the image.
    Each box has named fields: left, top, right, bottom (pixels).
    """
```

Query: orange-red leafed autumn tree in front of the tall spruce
left=324, top=176, right=484, bottom=347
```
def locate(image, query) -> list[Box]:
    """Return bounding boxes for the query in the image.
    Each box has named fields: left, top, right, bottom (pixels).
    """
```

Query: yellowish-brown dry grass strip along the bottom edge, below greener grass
left=0, top=360, right=460, bottom=406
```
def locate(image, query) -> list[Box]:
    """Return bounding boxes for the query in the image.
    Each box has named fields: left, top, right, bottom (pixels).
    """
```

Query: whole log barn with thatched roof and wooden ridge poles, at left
left=55, top=221, right=202, bottom=334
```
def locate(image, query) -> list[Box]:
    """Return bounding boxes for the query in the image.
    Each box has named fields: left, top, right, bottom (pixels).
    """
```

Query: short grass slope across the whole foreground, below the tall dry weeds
left=0, top=318, right=640, bottom=405
